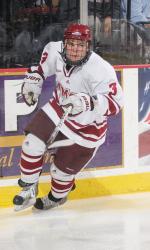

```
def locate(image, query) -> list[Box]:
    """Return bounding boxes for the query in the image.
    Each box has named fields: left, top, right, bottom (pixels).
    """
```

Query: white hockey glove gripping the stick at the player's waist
left=61, top=93, right=94, bottom=116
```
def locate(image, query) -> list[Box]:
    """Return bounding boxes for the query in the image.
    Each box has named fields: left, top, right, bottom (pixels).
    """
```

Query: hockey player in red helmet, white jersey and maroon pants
left=13, top=24, right=123, bottom=210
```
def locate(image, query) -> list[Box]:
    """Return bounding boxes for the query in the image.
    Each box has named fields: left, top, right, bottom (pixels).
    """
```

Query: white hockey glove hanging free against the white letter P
left=21, top=67, right=44, bottom=106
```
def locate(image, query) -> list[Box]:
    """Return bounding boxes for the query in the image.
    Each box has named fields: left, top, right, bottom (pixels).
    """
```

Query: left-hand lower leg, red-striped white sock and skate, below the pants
left=13, top=134, right=46, bottom=210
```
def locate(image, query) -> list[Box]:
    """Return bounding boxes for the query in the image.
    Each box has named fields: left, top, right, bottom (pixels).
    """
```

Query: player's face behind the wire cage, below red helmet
left=65, top=39, right=88, bottom=62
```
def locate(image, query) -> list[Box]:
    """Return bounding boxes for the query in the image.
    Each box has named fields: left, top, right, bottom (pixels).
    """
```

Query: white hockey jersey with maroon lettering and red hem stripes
left=39, top=41, right=123, bottom=148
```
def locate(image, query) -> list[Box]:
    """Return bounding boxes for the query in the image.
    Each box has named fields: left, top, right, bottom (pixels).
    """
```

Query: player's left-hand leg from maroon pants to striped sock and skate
left=13, top=111, right=55, bottom=210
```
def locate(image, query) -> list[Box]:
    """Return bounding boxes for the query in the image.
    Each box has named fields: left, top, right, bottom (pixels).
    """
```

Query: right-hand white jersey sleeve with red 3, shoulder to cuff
left=88, top=62, right=123, bottom=116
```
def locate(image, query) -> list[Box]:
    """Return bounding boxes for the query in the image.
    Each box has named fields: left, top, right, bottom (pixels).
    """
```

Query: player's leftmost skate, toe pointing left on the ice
left=13, top=179, right=38, bottom=211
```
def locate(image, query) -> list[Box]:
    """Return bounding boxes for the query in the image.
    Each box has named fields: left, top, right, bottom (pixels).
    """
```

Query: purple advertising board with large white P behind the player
left=0, top=69, right=123, bottom=177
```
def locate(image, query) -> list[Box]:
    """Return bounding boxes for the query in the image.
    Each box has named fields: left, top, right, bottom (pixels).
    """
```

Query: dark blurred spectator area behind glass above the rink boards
left=0, top=0, right=150, bottom=68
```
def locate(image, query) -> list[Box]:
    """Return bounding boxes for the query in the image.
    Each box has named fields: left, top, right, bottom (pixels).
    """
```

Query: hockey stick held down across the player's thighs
left=47, top=105, right=73, bottom=149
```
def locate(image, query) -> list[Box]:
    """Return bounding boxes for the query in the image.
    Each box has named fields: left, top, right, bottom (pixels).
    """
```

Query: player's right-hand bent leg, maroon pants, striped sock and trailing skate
left=34, top=144, right=95, bottom=210
